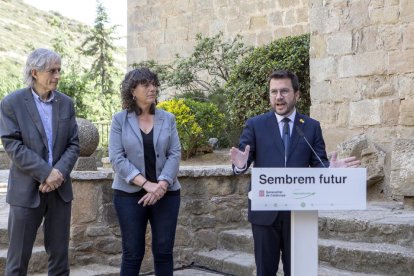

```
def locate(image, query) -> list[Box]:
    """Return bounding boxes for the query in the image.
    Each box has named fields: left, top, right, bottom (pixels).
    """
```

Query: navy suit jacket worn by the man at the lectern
left=239, top=111, right=329, bottom=225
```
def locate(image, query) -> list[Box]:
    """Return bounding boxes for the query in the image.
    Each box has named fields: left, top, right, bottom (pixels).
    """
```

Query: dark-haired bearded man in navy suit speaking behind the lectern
left=230, top=70, right=360, bottom=276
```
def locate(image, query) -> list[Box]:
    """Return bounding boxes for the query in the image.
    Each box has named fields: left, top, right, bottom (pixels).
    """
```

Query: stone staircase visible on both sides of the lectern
left=194, top=203, right=414, bottom=276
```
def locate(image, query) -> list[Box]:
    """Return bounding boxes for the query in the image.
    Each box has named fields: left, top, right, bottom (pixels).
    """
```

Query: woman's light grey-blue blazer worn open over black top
left=109, top=109, right=181, bottom=193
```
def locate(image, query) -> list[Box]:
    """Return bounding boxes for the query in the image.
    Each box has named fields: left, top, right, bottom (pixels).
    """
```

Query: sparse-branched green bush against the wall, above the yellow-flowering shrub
left=132, top=32, right=252, bottom=102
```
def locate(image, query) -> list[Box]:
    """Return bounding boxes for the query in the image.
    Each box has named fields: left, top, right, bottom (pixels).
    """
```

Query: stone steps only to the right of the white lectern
left=319, top=202, right=414, bottom=276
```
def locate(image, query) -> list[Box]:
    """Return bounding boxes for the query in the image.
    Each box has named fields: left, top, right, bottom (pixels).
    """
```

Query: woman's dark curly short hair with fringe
left=121, top=67, right=160, bottom=115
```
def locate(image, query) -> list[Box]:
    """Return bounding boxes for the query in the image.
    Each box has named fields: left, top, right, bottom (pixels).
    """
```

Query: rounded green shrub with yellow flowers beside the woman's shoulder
left=158, top=99, right=224, bottom=159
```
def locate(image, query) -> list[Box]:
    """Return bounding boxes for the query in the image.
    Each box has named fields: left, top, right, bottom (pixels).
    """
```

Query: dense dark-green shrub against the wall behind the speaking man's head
left=226, top=34, right=310, bottom=139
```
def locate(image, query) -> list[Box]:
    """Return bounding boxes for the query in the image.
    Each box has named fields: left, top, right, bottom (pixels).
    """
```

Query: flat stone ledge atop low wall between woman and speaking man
left=178, top=165, right=250, bottom=177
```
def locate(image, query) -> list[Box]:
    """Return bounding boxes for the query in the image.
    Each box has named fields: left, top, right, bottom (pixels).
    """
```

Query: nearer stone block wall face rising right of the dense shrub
left=309, top=0, right=414, bottom=197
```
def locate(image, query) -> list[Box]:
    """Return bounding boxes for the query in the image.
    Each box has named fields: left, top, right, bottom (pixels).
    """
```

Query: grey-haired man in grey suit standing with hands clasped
left=0, top=49, right=79, bottom=276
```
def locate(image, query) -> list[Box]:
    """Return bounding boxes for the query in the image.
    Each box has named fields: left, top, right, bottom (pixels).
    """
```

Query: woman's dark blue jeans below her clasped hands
left=114, top=191, right=180, bottom=276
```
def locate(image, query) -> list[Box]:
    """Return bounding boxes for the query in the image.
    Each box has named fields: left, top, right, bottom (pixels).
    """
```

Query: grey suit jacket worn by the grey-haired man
left=0, top=88, right=79, bottom=208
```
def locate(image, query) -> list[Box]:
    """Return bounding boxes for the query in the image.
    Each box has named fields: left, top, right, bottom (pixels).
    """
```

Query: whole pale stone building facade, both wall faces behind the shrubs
left=128, top=0, right=414, bottom=204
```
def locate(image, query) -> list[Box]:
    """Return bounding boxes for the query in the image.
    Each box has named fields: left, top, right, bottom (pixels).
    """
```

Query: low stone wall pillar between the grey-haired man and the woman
left=70, top=170, right=121, bottom=266
